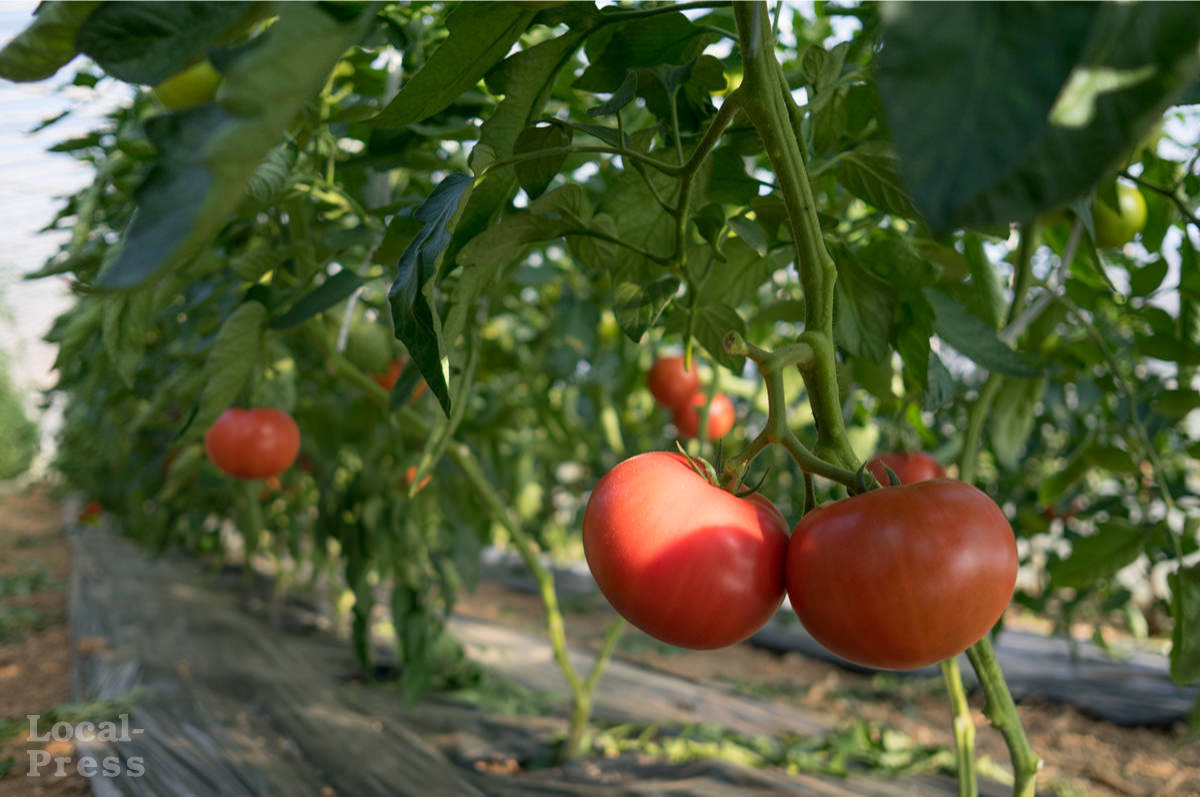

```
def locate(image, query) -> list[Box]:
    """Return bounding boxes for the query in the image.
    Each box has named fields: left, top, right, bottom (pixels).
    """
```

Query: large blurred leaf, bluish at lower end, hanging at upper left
left=97, top=2, right=369, bottom=289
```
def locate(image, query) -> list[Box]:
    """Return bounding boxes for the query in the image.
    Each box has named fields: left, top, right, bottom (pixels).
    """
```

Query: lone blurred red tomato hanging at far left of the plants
left=204, top=407, right=300, bottom=479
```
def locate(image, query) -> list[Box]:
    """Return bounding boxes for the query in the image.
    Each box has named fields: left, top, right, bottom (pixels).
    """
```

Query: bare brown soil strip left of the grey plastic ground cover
left=0, top=484, right=91, bottom=797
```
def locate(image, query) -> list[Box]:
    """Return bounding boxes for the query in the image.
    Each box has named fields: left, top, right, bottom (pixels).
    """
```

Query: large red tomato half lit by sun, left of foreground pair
left=583, top=451, right=787, bottom=651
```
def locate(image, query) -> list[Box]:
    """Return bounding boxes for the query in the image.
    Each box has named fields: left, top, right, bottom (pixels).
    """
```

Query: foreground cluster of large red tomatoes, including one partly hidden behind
left=583, top=451, right=1016, bottom=670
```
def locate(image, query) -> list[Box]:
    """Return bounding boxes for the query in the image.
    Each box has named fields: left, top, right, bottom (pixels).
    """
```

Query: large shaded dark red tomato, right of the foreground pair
left=787, top=479, right=1016, bottom=670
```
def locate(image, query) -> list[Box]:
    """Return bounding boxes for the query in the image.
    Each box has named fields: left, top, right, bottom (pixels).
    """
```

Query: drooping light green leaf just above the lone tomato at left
left=191, top=301, right=266, bottom=433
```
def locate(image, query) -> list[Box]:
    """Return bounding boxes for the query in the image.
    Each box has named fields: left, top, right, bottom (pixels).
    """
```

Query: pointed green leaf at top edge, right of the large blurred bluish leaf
left=373, top=2, right=538, bottom=127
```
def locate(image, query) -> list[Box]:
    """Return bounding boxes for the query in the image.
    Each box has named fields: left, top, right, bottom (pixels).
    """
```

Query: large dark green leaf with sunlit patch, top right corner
left=878, top=2, right=1200, bottom=232
